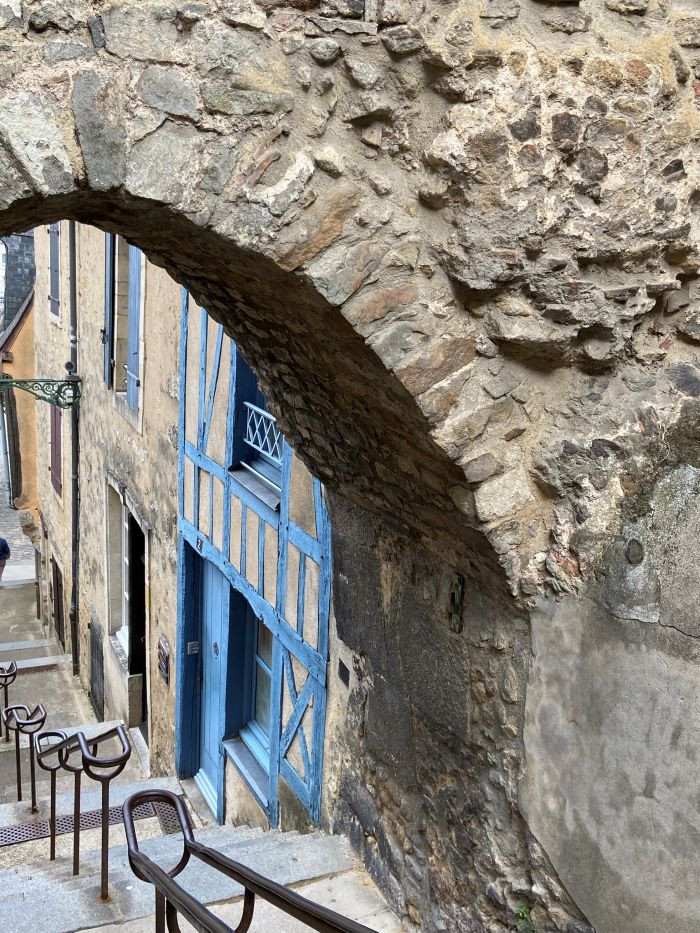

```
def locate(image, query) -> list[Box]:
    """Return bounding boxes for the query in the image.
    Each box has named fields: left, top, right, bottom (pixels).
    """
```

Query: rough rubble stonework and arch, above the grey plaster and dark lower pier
left=0, top=0, right=700, bottom=599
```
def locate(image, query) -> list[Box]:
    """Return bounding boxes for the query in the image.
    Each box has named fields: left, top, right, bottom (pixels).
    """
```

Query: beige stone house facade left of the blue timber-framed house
left=36, top=223, right=180, bottom=744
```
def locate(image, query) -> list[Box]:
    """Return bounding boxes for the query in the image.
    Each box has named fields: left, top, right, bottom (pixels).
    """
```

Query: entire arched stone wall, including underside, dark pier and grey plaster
left=0, top=0, right=700, bottom=933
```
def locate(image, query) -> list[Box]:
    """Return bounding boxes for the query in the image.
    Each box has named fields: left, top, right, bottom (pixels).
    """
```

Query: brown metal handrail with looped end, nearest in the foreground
left=122, top=790, right=380, bottom=933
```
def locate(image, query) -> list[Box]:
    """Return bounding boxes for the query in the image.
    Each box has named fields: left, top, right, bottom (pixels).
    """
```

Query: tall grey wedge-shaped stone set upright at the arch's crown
left=71, top=72, right=126, bottom=191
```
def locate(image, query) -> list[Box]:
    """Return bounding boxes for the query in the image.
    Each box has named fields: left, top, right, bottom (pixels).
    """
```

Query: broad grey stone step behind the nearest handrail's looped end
left=0, top=827, right=357, bottom=933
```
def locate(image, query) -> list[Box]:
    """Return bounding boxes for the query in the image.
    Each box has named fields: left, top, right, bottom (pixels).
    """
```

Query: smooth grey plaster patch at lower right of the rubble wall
left=521, top=466, right=700, bottom=933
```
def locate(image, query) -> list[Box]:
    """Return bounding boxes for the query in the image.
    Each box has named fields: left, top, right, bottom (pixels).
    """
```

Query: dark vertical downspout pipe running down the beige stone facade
left=66, top=226, right=80, bottom=676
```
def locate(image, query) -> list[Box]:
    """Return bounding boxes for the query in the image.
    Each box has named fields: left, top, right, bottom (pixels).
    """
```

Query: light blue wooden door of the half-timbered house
left=196, top=560, right=230, bottom=822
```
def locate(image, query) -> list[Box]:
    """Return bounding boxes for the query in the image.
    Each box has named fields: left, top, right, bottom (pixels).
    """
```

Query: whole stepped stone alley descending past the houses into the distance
left=0, top=438, right=401, bottom=933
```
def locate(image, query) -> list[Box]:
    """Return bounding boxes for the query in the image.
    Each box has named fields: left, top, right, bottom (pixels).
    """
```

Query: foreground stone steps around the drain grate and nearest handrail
left=0, top=723, right=402, bottom=933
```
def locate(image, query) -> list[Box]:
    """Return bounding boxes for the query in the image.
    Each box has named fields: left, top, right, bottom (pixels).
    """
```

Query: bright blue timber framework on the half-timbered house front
left=175, top=290, right=331, bottom=826
